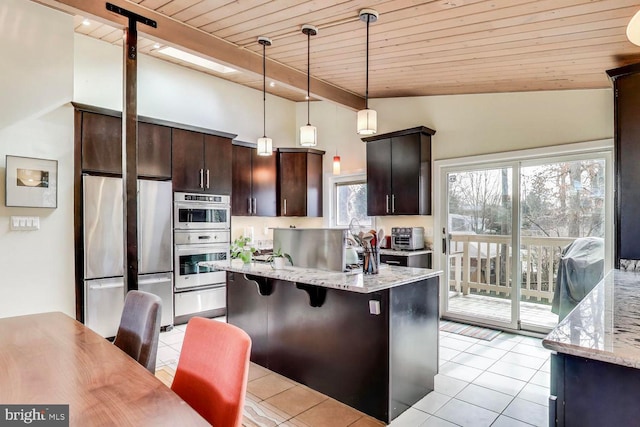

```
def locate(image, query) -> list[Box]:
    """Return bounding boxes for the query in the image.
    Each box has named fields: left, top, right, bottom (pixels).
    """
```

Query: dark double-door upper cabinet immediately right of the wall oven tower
left=231, top=141, right=276, bottom=216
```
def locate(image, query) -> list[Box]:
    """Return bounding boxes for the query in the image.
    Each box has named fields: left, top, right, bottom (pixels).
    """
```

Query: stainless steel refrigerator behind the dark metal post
left=82, top=175, right=173, bottom=337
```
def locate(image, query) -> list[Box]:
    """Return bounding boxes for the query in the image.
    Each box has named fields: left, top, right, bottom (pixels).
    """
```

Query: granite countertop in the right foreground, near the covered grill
left=542, top=270, right=640, bottom=368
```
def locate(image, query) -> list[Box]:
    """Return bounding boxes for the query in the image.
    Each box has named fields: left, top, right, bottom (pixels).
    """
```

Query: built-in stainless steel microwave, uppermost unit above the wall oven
left=173, top=193, right=231, bottom=230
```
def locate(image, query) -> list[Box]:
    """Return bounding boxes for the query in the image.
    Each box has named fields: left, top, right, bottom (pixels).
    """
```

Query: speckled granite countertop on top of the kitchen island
left=200, top=261, right=442, bottom=293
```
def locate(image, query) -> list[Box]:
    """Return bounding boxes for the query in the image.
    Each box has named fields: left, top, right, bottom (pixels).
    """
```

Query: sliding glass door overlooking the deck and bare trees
left=439, top=152, right=612, bottom=332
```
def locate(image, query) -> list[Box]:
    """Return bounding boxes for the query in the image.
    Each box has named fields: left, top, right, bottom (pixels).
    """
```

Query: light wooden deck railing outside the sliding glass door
left=449, top=234, right=575, bottom=303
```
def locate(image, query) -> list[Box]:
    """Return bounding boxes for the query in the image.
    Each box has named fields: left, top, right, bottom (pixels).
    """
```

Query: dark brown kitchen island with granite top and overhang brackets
left=204, top=262, right=440, bottom=422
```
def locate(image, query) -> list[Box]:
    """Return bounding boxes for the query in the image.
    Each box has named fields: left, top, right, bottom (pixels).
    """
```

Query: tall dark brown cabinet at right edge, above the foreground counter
left=607, top=64, right=640, bottom=268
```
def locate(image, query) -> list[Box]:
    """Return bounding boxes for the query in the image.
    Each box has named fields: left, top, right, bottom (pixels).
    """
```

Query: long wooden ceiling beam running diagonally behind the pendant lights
left=32, top=0, right=365, bottom=110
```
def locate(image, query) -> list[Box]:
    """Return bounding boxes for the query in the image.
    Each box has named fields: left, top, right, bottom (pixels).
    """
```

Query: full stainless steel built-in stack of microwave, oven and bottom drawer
left=174, top=193, right=231, bottom=323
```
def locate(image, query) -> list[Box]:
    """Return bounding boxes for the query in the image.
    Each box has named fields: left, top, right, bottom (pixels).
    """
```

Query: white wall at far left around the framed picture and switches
left=0, top=0, right=75, bottom=317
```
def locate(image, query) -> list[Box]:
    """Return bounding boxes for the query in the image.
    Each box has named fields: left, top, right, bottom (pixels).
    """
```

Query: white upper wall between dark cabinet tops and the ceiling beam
left=74, top=34, right=296, bottom=147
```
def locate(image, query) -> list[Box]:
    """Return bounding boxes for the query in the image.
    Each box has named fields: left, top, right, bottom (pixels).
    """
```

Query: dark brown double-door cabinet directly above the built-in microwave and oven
left=171, top=128, right=232, bottom=194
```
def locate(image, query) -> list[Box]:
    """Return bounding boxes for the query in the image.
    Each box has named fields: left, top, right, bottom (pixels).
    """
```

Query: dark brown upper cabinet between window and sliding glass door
left=362, top=126, right=436, bottom=216
